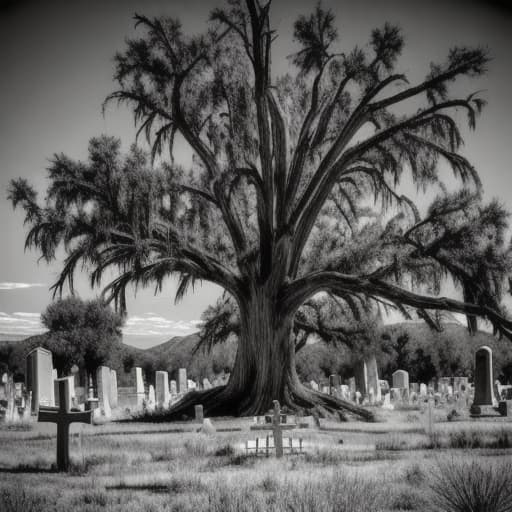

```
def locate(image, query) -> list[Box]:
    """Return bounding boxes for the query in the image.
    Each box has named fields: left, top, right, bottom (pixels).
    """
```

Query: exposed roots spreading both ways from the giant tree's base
left=130, top=385, right=375, bottom=422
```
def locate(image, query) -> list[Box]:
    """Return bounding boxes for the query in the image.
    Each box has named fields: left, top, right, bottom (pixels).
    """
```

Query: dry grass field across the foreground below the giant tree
left=0, top=411, right=512, bottom=512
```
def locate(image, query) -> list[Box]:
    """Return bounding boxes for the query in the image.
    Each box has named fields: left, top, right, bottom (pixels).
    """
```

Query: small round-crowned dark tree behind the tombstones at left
left=41, top=297, right=124, bottom=376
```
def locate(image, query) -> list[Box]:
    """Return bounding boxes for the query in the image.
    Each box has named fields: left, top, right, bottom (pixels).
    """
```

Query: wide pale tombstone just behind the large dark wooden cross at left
left=25, top=347, right=55, bottom=412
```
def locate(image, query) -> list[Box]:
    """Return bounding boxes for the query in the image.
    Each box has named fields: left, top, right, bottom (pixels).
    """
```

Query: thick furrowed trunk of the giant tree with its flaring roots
left=138, top=284, right=373, bottom=421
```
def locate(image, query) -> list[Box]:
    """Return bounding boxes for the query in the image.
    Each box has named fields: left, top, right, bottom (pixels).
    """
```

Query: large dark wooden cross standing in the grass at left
left=37, top=379, right=92, bottom=471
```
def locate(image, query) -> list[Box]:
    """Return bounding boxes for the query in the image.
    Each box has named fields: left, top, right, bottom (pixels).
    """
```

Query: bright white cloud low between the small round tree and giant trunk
left=123, top=313, right=201, bottom=336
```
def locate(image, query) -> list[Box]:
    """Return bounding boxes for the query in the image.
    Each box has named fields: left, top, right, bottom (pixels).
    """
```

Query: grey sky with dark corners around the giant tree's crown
left=0, top=0, right=512, bottom=348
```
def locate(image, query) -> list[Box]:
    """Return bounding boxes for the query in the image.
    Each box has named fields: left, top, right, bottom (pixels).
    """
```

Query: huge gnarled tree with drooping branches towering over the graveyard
left=10, top=0, right=512, bottom=417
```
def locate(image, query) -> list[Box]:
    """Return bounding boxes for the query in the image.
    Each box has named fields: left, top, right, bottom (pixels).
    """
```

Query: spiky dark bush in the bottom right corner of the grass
left=429, top=459, right=512, bottom=512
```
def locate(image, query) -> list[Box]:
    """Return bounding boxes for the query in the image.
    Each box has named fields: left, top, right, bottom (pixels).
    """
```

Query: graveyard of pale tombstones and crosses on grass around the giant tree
left=0, top=338, right=512, bottom=511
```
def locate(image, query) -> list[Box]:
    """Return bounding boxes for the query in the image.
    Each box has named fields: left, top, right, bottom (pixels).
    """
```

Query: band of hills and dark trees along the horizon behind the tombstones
left=0, top=322, right=512, bottom=386
